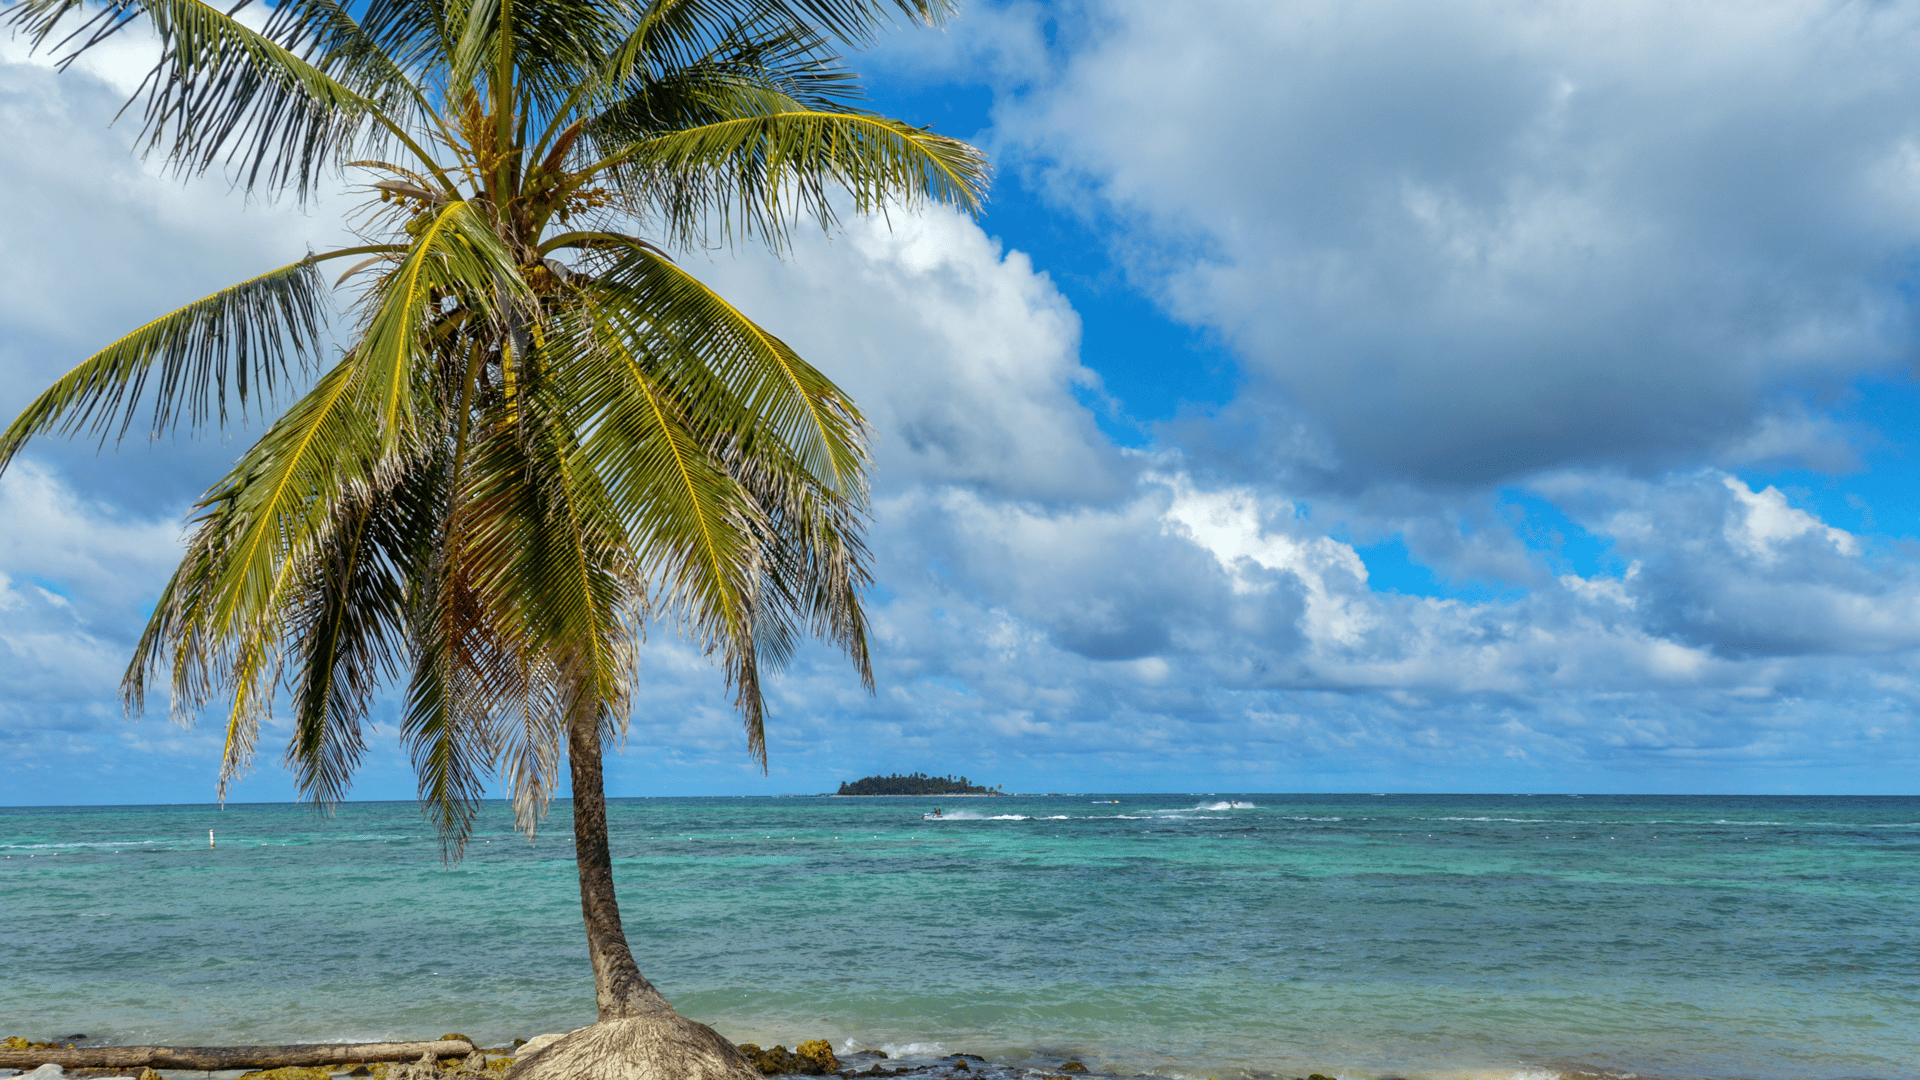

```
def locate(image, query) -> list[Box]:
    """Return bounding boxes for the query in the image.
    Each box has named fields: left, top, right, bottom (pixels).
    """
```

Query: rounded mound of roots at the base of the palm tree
left=507, top=1009, right=760, bottom=1080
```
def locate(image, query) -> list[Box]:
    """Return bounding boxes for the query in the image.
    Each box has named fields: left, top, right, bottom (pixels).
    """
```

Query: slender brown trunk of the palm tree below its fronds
left=566, top=719, right=672, bottom=1020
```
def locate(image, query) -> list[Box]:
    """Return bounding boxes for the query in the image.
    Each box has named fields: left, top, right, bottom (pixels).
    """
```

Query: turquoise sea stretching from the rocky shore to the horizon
left=0, top=794, right=1920, bottom=1080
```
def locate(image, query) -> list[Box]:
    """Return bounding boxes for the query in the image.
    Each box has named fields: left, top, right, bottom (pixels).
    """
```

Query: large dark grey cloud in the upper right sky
left=998, top=0, right=1920, bottom=486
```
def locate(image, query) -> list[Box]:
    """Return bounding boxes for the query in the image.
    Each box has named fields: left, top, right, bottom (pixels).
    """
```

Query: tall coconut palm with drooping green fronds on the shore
left=0, top=0, right=985, bottom=1076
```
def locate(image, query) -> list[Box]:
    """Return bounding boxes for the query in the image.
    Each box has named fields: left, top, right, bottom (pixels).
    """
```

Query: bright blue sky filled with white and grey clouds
left=0, top=0, right=1920, bottom=805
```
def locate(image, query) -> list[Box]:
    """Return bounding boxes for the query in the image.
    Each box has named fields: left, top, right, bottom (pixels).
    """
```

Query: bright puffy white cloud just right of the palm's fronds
left=689, top=208, right=1133, bottom=502
